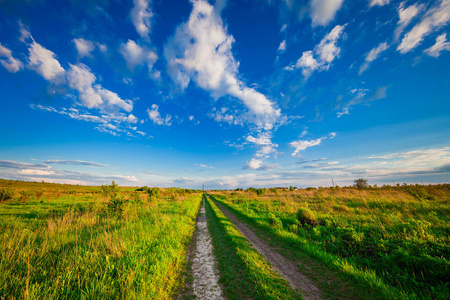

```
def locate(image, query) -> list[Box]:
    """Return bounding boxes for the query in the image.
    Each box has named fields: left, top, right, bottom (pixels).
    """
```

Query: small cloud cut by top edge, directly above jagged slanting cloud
left=309, top=0, right=344, bottom=27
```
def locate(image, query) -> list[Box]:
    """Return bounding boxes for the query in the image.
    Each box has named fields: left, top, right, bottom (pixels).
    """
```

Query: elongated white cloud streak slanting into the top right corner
left=397, top=0, right=450, bottom=54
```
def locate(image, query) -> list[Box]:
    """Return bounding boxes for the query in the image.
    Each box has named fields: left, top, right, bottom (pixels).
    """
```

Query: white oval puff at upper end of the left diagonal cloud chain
left=28, top=40, right=65, bottom=84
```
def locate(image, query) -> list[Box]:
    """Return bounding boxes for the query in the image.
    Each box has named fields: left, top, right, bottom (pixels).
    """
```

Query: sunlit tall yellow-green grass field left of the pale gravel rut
left=0, top=180, right=201, bottom=299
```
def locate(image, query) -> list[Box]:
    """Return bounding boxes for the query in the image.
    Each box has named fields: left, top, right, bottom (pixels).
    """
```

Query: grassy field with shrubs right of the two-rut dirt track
left=212, top=182, right=450, bottom=299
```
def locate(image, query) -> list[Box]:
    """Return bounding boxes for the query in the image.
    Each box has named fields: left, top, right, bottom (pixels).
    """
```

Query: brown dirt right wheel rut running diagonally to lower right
left=214, top=197, right=322, bottom=300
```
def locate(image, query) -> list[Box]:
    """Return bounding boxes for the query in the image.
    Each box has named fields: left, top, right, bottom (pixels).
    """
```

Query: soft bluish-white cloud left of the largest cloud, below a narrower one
left=119, top=40, right=158, bottom=72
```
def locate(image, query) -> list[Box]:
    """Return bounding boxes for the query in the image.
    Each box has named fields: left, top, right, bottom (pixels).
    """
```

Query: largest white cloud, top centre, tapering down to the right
left=164, top=0, right=281, bottom=129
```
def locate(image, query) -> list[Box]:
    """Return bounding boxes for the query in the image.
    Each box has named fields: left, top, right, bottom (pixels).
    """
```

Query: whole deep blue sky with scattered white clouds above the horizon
left=0, top=0, right=450, bottom=189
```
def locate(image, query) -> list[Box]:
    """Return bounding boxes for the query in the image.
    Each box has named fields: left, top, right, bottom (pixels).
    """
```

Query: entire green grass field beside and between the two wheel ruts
left=0, top=180, right=450, bottom=299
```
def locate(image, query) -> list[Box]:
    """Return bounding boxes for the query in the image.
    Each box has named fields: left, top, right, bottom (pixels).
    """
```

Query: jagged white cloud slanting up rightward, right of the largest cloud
left=285, top=25, right=346, bottom=78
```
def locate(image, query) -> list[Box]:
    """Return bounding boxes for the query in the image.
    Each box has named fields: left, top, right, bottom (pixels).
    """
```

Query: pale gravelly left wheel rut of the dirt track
left=192, top=200, right=225, bottom=299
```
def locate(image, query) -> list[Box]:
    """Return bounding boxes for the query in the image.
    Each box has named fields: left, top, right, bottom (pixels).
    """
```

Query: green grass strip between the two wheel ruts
left=205, top=193, right=301, bottom=299
